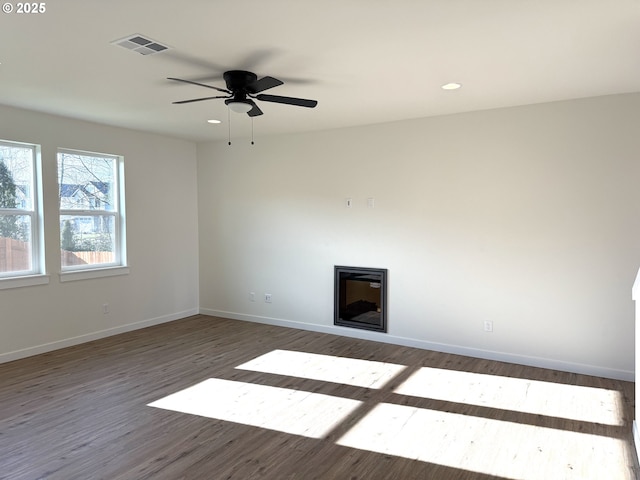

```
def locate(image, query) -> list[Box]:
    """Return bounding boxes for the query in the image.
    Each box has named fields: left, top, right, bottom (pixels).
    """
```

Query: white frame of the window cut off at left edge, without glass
left=0, top=140, right=49, bottom=290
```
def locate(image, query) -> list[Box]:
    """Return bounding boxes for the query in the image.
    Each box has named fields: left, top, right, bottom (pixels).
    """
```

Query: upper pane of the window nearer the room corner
left=58, top=152, right=117, bottom=211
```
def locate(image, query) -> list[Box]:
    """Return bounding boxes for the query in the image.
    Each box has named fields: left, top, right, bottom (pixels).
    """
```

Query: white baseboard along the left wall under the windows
left=0, top=308, right=198, bottom=363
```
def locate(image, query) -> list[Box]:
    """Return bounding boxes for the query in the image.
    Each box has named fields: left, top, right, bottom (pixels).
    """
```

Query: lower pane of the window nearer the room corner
left=60, top=215, right=116, bottom=267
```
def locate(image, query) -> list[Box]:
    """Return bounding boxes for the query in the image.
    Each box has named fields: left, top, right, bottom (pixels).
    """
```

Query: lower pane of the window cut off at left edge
left=0, top=215, right=32, bottom=275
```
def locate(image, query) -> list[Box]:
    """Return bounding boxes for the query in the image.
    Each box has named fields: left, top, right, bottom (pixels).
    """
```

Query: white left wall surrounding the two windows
left=0, top=106, right=198, bottom=361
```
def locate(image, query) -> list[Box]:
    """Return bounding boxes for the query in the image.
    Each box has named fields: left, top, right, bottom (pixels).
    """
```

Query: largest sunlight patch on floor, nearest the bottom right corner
left=337, top=403, right=632, bottom=480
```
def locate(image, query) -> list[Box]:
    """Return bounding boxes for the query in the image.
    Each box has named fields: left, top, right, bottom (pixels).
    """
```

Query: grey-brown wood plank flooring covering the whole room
left=0, top=315, right=638, bottom=480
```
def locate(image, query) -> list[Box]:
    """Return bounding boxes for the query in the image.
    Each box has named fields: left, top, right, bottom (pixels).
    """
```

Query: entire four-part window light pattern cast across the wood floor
left=149, top=350, right=634, bottom=480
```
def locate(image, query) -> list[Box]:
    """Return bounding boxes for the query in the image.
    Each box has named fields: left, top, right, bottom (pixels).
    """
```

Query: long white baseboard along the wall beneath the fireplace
left=200, top=308, right=635, bottom=382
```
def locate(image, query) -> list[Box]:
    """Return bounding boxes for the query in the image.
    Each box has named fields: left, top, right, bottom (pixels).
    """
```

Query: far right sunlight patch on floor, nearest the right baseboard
left=394, top=367, right=624, bottom=426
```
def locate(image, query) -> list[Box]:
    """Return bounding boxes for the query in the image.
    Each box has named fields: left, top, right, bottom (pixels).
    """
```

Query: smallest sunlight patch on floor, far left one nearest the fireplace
left=236, top=350, right=406, bottom=388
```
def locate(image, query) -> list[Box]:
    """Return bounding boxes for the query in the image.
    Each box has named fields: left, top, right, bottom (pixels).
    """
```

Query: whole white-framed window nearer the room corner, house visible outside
left=58, top=150, right=126, bottom=278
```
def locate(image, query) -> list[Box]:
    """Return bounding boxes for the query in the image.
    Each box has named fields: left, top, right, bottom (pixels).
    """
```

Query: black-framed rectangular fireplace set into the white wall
left=333, top=266, right=387, bottom=333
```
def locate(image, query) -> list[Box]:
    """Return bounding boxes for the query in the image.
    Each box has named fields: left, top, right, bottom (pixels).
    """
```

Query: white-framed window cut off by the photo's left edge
left=0, top=141, right=44, bottom=282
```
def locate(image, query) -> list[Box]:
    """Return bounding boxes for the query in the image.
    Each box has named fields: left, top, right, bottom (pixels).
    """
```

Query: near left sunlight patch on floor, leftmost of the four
left=149, top=378, right=362, bottom=438
